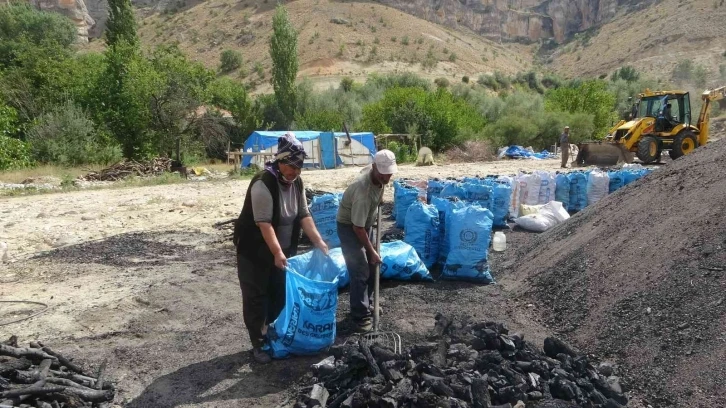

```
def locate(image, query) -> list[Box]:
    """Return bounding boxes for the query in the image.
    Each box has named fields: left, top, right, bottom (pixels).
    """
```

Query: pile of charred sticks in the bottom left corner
left=0, top=336, right=116, bottom=408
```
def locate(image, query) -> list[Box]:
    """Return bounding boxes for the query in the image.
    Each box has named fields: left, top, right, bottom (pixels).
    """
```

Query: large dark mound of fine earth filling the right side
left=500, top=140, right=726, bottom=407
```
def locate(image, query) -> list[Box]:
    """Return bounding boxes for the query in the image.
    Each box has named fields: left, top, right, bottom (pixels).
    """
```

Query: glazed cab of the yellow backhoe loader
left=638, top=92, right=691, bottom=132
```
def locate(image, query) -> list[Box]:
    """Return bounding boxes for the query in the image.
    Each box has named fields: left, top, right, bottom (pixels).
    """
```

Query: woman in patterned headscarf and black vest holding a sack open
left=234, top=132, right=328, bottom=363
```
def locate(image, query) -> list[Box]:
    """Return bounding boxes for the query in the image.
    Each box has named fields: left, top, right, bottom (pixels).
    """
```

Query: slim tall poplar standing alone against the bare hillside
left=270, top=6, right=298, bottom=126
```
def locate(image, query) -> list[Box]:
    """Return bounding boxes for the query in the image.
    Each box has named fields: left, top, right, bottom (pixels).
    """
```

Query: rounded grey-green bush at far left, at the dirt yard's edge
left=27, top=102, right=122, bottom=166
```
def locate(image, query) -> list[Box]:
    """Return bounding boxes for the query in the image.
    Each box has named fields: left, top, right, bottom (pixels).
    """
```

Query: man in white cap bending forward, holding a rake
left=337, top=150, right=398, bottom=333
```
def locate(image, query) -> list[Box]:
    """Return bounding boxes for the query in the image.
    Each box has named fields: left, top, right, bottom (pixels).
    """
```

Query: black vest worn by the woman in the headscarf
left=233, top=170, right=305, bottom=262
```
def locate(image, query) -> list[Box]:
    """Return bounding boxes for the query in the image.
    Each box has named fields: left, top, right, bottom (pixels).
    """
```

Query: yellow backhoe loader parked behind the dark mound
left=575, top=86, right=726, bottom=166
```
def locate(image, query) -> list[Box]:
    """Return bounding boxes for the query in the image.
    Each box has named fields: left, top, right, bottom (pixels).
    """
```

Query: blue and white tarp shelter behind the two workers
left=241, top=130, right=377, bottom=169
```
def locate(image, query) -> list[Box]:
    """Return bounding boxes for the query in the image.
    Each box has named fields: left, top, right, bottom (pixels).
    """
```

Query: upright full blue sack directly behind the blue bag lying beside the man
left=404, top=201, right=439, bottom=268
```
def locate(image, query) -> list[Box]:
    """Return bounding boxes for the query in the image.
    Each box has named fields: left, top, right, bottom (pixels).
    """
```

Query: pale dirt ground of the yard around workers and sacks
left=0, top=160, right=559, bottom=408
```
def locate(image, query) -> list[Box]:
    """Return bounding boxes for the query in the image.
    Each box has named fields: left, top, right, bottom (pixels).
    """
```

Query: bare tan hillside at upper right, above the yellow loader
left=549, top=0, right=726, bottom=83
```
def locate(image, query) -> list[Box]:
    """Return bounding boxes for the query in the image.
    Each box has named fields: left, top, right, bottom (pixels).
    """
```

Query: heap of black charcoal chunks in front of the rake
left=295, top=315, right=628, bottom=408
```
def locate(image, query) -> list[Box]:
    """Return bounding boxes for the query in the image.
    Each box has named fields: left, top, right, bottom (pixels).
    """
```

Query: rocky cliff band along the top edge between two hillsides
left=378, top=0, right=658, bottom=42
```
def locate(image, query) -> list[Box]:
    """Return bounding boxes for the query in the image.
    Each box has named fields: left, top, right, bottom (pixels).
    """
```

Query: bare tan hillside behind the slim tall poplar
left=129, top=0, right=532, bottom=91
